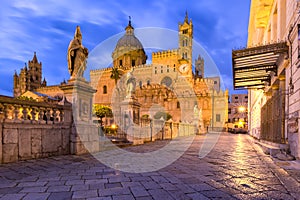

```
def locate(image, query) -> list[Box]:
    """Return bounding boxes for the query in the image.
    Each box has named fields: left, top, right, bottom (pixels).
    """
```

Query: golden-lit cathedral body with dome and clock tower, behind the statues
left=90, top=14, right=228, bottom=129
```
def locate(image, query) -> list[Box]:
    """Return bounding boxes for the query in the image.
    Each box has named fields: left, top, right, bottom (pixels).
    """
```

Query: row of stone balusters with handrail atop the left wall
left=0, top=95, right=72, bottom=124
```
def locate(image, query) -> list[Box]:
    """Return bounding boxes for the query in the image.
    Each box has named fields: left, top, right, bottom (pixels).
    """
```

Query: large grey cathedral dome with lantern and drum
left=112, top=17, right=147, bottom=67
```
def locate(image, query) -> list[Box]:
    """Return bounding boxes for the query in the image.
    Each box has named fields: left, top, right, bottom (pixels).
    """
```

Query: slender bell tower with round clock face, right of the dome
left=178, top=12, right=193, bottom=77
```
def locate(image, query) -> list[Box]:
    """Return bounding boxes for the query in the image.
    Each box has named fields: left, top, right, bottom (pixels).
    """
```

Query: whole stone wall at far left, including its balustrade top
left=0, top=96, right=72, bottom=163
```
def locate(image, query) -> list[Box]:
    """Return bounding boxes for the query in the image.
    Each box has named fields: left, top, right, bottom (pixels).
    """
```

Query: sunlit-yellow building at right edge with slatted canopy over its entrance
left=233, top=0, right=300, bottom=158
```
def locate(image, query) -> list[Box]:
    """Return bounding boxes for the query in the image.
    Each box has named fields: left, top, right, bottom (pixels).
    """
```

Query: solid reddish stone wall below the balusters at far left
left=0, top=122, right=70, bottom=163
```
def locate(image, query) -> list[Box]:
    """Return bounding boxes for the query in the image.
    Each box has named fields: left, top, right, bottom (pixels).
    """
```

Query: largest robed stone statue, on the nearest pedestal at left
left=68, top=26, right=88, bottom=79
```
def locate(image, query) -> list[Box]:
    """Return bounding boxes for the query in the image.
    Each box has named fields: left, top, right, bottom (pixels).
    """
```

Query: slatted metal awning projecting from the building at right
left=232, top=42, right=289, bottom=89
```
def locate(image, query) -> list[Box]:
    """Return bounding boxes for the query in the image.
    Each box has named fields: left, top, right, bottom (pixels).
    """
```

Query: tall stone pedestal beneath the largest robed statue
left=60, top=77, right=99, bottom=154
